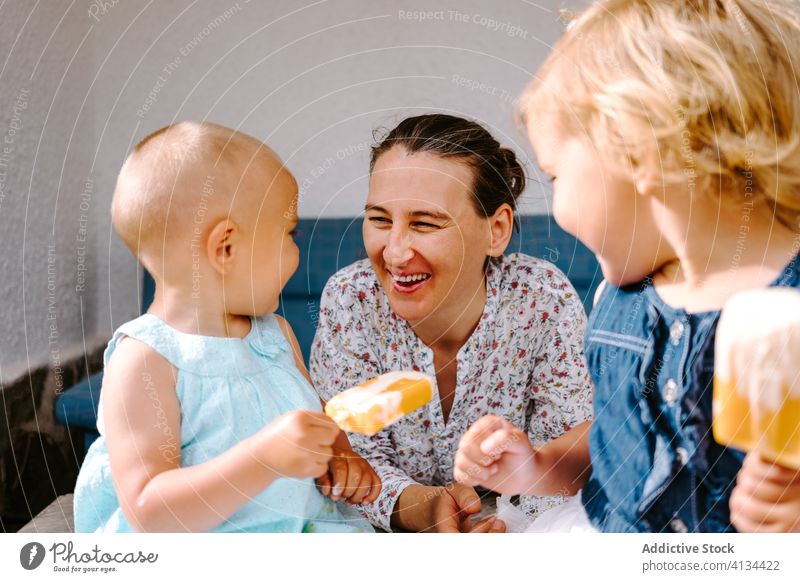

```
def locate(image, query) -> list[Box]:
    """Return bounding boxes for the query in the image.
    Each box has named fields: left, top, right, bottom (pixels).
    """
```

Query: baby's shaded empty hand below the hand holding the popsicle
left=317, top=449, right=381, bottom=503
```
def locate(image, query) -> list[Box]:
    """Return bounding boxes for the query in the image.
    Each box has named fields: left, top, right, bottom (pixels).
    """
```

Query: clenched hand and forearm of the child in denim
left=454, top=415, right=591, bottom=495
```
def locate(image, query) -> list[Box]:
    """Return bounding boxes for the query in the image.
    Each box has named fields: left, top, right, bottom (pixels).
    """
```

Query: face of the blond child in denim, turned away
left=528, top=116, right=663, bottom=285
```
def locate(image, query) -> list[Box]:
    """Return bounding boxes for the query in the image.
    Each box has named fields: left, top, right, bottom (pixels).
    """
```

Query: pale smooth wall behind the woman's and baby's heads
left=87, top=0, right=562, bottom=225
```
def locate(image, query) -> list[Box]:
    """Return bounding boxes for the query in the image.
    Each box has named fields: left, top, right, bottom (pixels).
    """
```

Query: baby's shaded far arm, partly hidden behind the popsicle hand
left=275, top=315, right=381, bottom=503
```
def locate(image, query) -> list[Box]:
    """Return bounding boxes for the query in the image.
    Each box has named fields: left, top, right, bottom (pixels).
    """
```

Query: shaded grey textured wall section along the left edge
left=0, top=2, right=126, bottom=388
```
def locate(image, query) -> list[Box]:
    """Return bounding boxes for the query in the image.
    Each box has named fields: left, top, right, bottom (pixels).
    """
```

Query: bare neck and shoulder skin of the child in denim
left=654, top=201, right=800, bottom=313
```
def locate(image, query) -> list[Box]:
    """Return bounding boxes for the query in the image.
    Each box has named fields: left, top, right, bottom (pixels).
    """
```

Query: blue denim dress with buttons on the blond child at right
left=581, top=257, right=800, bottom=533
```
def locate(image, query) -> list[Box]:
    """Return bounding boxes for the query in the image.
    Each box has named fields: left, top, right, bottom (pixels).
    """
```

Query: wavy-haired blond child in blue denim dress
left=455, top=0, right=800, bottom=532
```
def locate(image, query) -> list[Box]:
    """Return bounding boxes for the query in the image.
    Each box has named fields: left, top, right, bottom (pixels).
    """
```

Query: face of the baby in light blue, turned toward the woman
left=240, top=160, right=300, bottom=316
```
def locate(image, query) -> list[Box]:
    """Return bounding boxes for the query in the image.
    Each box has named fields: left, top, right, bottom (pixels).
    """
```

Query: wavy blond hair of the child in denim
left=520, top=0, right=800, bottom=229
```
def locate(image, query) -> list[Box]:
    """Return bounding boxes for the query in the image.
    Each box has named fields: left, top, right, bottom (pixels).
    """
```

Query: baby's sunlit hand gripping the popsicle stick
left=255, top=410, right=339, bottom=479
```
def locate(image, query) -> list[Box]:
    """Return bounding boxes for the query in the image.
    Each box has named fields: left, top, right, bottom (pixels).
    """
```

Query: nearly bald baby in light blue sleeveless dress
left=75, top=122, right=380, bottom=532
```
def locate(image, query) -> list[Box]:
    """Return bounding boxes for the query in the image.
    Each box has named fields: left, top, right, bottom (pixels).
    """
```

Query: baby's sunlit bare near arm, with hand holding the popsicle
left=102, top=338, right=339, bottom=531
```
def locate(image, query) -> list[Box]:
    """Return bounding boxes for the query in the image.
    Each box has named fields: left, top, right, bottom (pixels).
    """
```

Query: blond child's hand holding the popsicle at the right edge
left=730, top=452, right=800, bottom=532
